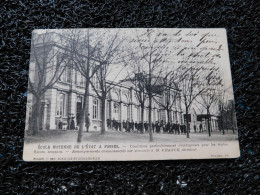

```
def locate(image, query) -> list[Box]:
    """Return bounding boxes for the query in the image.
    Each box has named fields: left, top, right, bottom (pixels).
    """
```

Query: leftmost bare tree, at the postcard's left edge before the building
left=28, top=30, right=70, bottom=135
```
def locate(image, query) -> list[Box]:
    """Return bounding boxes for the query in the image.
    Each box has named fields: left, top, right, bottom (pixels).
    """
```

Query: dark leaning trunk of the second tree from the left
left=77, top=78, right=89, bottom=142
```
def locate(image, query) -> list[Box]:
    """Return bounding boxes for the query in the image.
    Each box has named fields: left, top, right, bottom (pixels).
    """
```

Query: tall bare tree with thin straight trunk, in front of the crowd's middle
left=124, top=29, right=173, bottom=141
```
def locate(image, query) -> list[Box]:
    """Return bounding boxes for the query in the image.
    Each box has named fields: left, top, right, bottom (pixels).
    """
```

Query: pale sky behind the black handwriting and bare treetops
left=31, top=28, right=233, bottom=99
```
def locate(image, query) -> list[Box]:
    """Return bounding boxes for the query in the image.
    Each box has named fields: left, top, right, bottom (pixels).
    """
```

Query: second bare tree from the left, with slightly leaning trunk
left=65, top=29, right=104, bottom=142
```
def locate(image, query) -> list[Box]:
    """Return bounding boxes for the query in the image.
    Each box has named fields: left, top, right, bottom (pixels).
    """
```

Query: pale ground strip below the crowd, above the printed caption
left=25, top=130, right=238, bottom=143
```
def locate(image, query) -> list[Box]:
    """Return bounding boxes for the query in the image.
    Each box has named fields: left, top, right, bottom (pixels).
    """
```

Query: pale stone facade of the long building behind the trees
left=27, top=64, right=183, bottom=130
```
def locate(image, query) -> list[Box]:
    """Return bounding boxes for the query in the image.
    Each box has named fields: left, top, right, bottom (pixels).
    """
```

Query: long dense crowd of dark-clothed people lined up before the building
left=107, top=119, right=191, bottom=134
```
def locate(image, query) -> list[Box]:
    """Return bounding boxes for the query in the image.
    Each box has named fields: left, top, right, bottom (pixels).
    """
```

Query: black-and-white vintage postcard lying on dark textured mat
left=23, top=28, right=240, bottom=161
